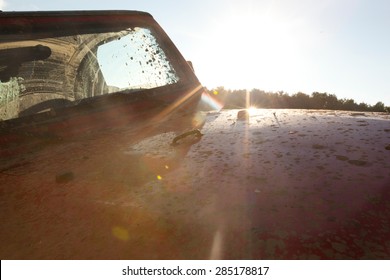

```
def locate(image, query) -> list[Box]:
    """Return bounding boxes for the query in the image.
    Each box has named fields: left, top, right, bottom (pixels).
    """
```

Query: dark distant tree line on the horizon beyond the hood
left=207, top=87, right=390, bottom=113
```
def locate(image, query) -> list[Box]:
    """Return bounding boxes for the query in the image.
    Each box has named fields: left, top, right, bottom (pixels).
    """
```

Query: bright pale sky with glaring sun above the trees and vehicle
left=0, top=0, right=390, bottom=106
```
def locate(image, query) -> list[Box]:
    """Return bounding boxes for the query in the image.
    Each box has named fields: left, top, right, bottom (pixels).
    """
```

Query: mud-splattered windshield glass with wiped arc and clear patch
left=0, top=17, right=179, bottom=120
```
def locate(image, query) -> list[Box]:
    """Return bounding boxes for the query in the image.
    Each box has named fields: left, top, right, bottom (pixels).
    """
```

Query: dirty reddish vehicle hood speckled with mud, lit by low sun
left=0, top=110, right=390, bottom=259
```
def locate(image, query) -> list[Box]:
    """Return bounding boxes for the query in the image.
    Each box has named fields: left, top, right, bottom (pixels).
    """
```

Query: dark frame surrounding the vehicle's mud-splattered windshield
left=0, top=11, right=200, bottom=122
